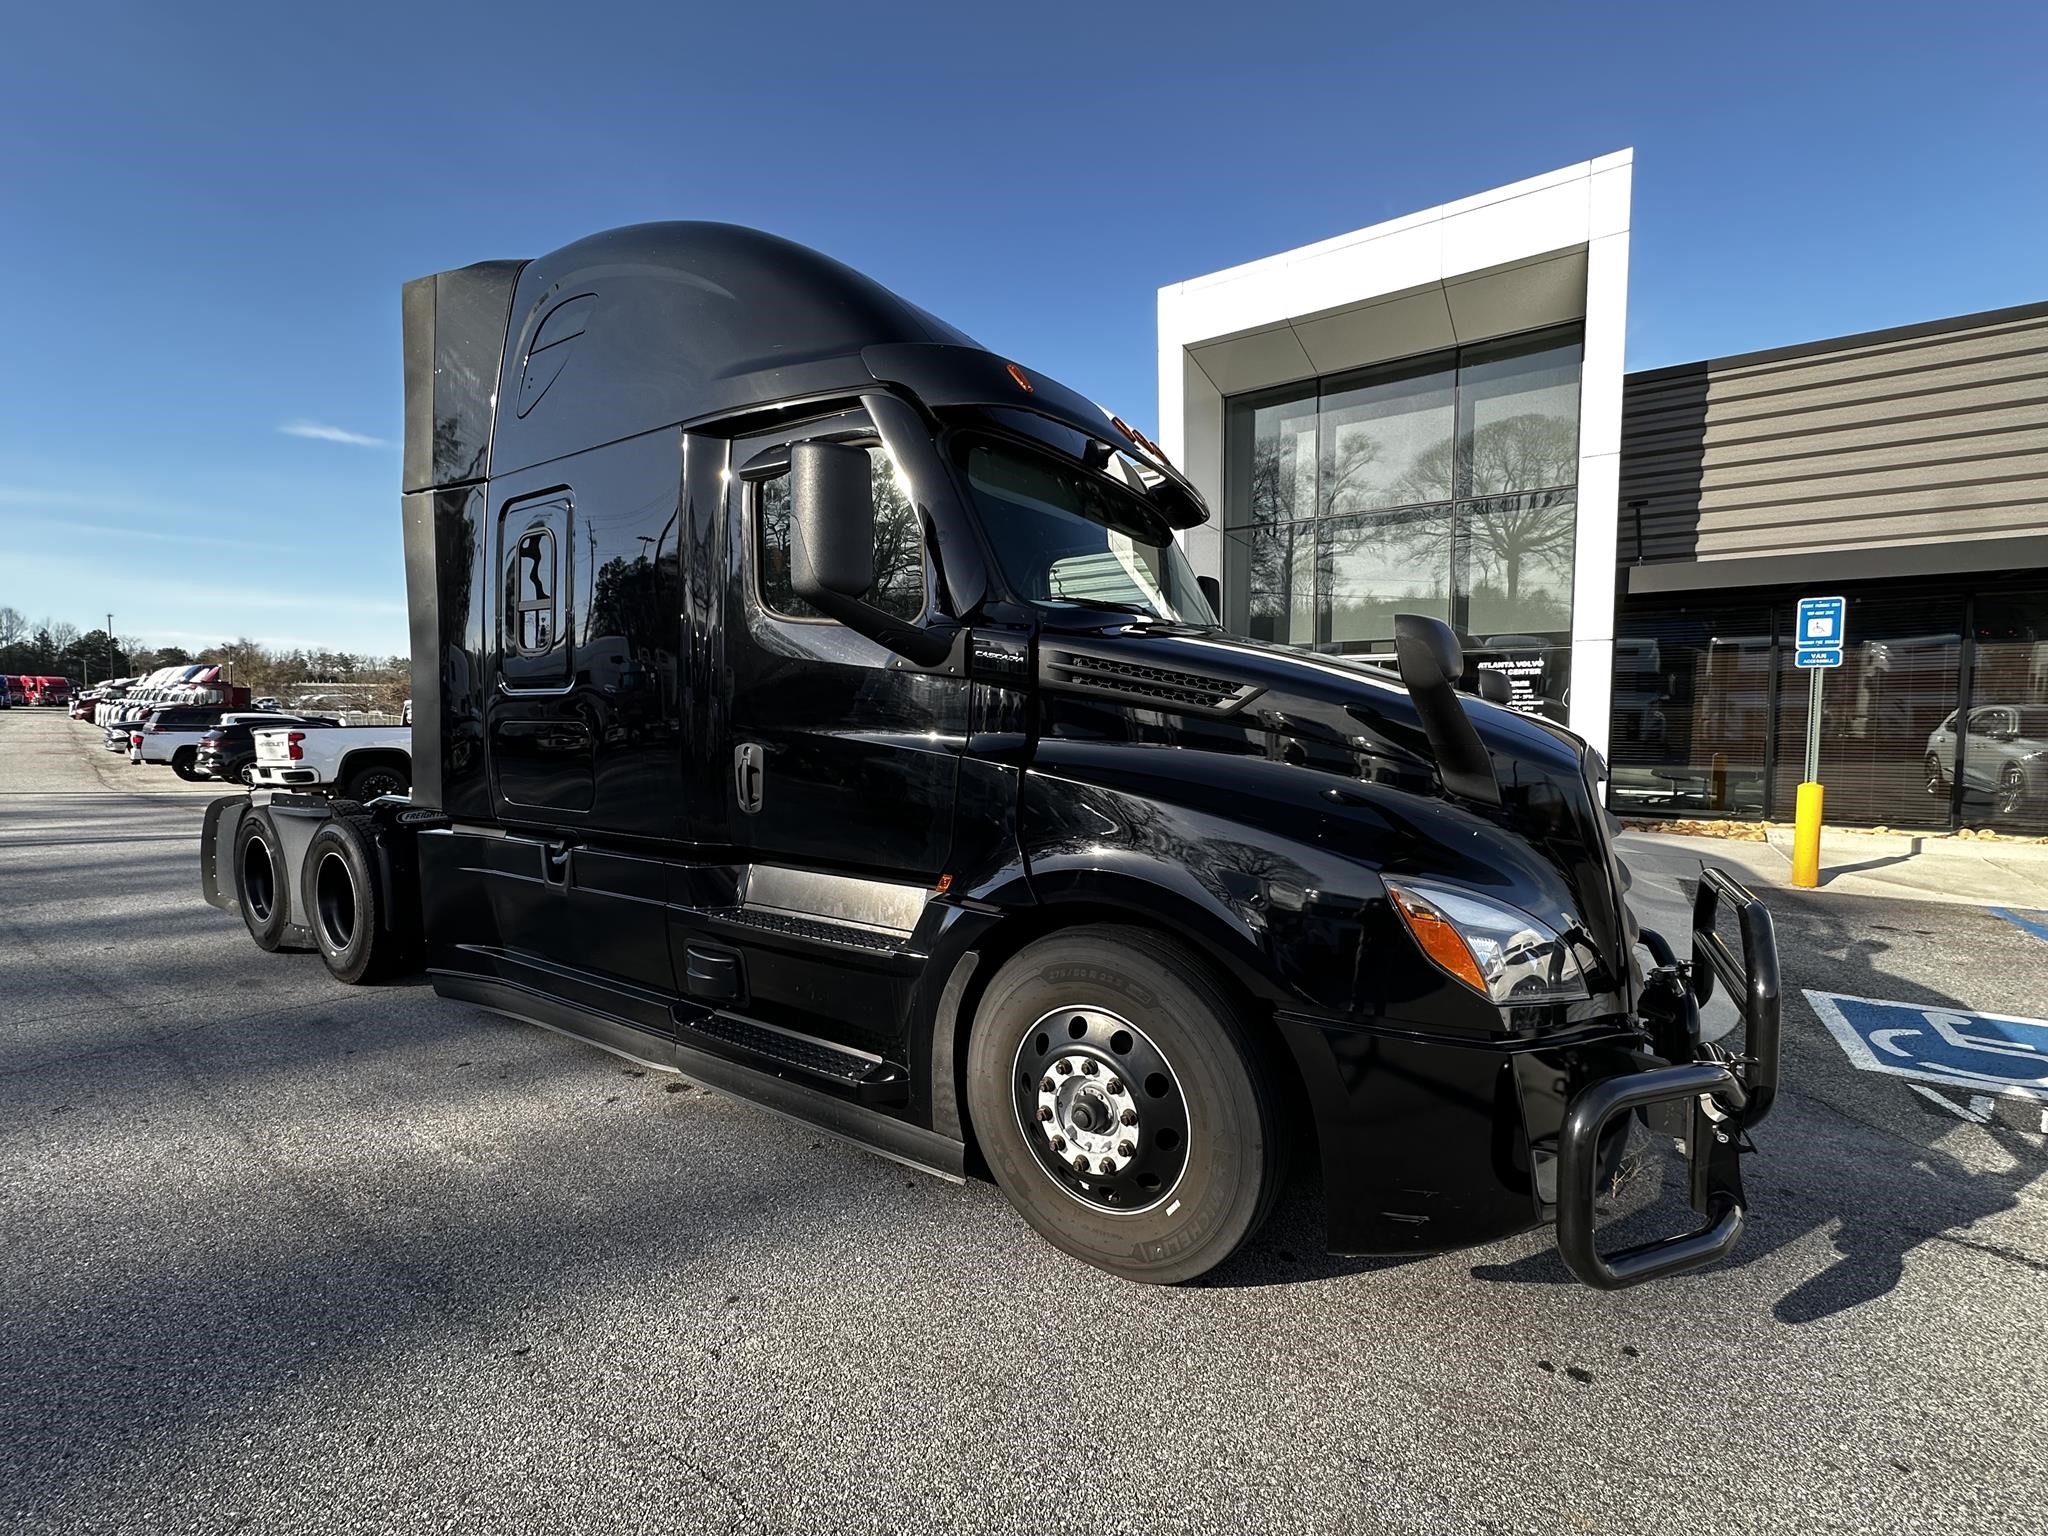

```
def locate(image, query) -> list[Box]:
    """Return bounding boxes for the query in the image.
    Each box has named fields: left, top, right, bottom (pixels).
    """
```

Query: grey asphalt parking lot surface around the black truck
left=0, top=711, right=2048, bottom=1532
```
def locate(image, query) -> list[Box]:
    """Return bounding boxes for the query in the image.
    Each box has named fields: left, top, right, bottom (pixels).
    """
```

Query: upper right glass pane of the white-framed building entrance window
left=1456, top=334, right=1583, bottom=496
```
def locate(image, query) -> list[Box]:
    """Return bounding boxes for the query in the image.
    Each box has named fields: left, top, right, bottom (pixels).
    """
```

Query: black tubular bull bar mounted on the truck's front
left=1556, top=868, right=1780, bottom=1290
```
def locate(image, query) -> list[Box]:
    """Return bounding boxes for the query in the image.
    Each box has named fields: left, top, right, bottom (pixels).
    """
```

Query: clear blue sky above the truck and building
left=0, top=0, right=2048, bottom=651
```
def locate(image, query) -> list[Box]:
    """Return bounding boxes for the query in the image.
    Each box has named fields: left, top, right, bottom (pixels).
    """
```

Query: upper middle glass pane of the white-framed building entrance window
left=1317, top=356, right=1458, bottom=516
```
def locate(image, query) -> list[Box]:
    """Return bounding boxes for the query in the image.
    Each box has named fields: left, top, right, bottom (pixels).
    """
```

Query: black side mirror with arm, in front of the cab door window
left=788, top=442, right=958, bottom=668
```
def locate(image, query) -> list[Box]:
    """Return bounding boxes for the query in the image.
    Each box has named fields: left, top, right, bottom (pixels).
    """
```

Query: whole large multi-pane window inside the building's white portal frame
left=1225, top=330, right=1581, bottom=717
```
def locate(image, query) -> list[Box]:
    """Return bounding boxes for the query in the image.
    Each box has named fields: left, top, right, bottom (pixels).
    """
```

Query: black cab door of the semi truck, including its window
left=723, top=410, right=969, bottom=1055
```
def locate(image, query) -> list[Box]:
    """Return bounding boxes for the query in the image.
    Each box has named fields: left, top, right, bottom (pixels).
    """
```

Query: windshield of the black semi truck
left=961, top=438, right=1217, bottom=627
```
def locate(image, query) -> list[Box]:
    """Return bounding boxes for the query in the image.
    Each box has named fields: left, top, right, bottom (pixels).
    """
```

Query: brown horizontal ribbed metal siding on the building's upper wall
left=1616, top=305, right=2048, bottom=571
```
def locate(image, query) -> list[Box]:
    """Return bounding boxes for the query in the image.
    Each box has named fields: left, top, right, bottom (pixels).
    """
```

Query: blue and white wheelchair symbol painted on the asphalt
left=1806, top=991, right=2048, bottom=1100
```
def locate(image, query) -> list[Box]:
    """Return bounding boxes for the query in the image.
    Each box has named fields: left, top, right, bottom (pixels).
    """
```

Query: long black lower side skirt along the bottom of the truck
left=428, top=969, right=967, bottom=1184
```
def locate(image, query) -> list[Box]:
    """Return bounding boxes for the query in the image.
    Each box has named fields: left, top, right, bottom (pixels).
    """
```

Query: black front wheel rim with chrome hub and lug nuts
left=1012, top=1004, right=1194, bottom=1214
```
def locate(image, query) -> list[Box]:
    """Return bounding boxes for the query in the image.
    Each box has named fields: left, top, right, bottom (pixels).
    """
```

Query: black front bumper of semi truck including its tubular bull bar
left=1276, top=870, right=1778, bottom=1288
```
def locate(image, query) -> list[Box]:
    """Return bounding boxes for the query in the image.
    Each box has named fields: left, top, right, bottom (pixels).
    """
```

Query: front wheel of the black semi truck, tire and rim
left=967, top=926, right=1286, bottom=1284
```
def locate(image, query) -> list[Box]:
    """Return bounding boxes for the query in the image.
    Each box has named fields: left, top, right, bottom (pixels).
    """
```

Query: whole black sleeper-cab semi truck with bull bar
left=203, top=223, right=1778, bottom=1288
